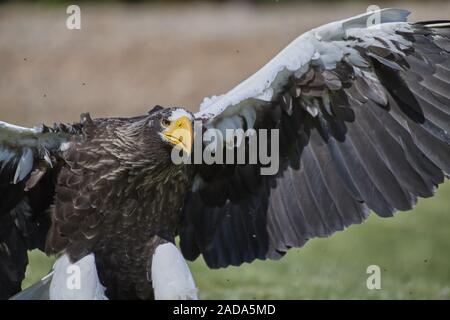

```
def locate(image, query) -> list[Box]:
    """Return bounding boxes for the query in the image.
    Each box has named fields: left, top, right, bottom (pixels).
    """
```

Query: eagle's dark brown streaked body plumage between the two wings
left=47, top=116, right=189, bottom=299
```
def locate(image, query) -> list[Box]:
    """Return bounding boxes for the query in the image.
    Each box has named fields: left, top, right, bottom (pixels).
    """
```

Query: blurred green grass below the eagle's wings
left=24, top=182, right=450, bottom=299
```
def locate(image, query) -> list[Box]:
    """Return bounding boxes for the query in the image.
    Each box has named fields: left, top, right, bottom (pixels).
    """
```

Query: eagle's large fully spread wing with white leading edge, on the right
left=180, top=9, right=450, bottom=268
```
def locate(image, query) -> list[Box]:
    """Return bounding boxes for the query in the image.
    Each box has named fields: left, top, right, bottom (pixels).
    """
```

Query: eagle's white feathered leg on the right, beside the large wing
left=151, top=242, right=198, bottom=300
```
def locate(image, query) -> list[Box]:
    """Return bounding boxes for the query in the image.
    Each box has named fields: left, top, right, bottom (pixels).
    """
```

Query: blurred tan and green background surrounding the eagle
left=0, top=0, right=450, bottom=299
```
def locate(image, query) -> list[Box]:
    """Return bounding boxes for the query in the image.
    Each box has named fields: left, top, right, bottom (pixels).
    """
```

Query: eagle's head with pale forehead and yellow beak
left=150, top=106, right=194, bottom=155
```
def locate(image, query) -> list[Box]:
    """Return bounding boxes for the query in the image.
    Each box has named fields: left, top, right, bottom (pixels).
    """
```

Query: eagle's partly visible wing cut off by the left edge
left=0, top=122, right=77, bottom=299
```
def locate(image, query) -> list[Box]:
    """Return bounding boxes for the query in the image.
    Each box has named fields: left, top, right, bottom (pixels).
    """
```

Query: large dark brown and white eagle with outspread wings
left=0, top=9, right=450, bottom=299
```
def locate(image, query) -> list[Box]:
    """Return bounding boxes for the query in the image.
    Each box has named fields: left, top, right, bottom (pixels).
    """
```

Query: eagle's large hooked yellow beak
left=162, top=116, right=194, bottom=155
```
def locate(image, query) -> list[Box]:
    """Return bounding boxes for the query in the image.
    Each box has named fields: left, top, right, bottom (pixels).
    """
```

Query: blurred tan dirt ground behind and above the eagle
left=0, top=1, right=450, bottom=126
